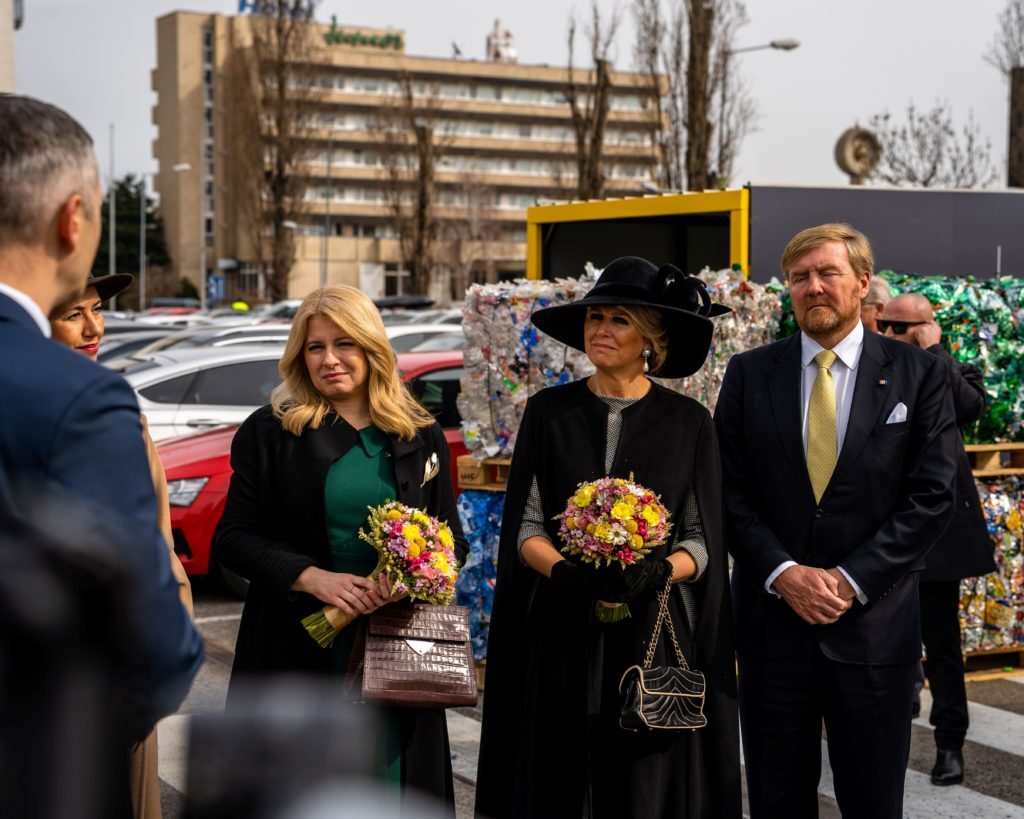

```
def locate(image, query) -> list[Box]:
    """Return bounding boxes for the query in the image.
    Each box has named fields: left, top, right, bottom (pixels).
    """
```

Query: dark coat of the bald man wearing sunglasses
left=921, top=344, right=995, bottom=583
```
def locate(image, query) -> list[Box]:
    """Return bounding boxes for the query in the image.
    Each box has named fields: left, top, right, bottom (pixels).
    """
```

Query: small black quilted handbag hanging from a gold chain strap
left=618, top=577, right=708, bottom=731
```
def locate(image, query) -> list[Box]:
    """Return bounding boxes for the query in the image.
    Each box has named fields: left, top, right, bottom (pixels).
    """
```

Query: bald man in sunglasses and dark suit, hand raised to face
left=879, top=293, right=995, bottom=785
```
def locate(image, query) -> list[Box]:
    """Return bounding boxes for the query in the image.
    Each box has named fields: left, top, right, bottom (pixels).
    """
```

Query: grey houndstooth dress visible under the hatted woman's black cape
left=518, top=395, right=708, bottom=631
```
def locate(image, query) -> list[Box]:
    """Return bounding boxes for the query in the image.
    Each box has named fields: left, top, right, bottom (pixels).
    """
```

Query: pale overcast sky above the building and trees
left=14, top=0, right=1008, bottom=184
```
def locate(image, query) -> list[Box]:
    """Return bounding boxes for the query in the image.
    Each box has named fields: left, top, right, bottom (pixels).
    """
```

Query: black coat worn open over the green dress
left=214, top=406, right=467, bottom=802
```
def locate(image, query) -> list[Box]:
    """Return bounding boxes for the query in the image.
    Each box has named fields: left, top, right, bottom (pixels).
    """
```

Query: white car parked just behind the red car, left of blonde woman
left=121, top=347, right=282, bottom=441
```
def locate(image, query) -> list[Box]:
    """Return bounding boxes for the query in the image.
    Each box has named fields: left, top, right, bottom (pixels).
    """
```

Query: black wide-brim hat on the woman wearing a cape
left=530, top=256, right=730, bottom=378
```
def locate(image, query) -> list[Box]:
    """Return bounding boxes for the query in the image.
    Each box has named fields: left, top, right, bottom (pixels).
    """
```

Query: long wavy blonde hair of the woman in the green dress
left=270, top=285, right=434, bottom=440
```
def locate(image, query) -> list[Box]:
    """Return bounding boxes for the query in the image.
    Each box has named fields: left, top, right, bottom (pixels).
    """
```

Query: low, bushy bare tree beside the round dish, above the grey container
left=868, top=102, right=996, bottom=187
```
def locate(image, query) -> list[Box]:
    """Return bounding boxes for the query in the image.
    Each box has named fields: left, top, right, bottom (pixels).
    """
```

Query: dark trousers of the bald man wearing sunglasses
left=921, top=580, right=968, bottom=750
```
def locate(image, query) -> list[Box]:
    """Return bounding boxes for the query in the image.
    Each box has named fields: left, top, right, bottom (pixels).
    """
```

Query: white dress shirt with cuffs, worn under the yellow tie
left=765, top=321, right=867, bottom=604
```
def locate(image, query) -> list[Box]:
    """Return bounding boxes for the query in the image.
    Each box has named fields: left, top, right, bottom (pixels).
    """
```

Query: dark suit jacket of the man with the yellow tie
left=715, top=333, right=959, bottom=664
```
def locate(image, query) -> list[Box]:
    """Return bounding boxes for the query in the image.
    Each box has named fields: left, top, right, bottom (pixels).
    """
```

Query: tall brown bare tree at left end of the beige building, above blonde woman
left=231, top=3, right=317, bottom=300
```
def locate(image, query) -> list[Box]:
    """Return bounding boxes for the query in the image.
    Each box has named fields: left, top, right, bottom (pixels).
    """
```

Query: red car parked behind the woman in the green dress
left=157, top=350, right=466, bottom=589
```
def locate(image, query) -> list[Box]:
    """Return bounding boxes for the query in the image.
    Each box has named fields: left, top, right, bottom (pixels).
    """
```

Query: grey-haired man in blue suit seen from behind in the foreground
left=0, top=94, right=203, bottom=737
